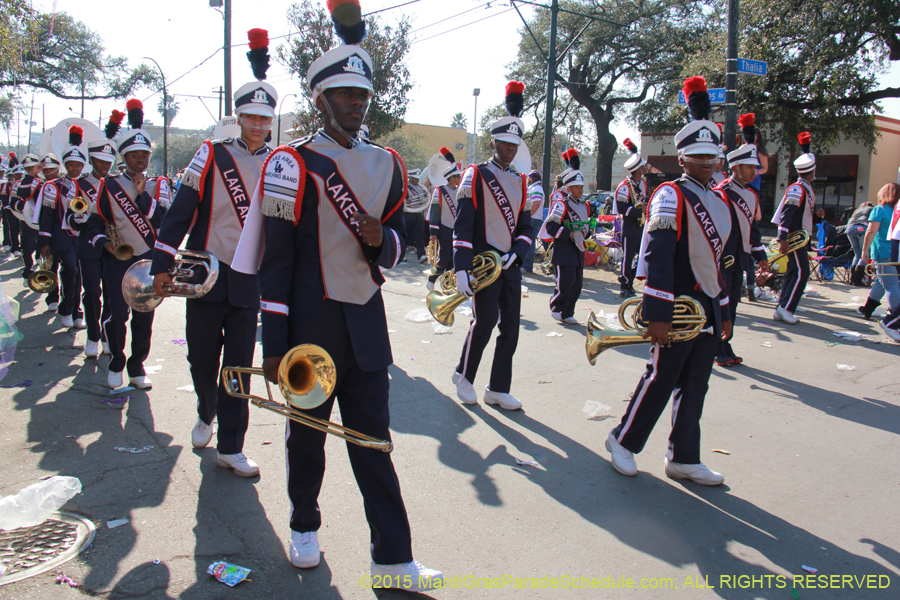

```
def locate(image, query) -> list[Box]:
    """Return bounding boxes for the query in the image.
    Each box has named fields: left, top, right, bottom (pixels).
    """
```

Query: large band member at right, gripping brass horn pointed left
left=606, top=77, right=731, bottom=485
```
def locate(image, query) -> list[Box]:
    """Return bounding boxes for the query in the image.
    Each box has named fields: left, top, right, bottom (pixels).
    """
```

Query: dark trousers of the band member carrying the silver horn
left=185, top=298, right=259, bottom=454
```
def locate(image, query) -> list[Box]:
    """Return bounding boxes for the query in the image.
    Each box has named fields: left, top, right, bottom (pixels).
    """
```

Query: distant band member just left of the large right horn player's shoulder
left=613, top=139, right=650, bottom=298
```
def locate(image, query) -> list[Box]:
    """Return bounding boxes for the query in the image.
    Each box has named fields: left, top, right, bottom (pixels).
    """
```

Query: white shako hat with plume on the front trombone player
left=306, top=0, right=375, bottom=104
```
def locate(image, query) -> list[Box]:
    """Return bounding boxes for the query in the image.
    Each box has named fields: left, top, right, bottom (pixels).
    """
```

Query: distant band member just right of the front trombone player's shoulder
left=427, top=147, right=462, bottom=290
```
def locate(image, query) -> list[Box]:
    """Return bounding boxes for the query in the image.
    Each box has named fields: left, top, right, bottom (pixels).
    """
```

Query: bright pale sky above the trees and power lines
left=13, top=0, right=900, bottom=151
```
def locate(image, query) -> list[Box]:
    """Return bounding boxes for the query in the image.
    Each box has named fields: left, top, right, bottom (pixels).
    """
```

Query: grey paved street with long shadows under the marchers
left=0, top=254, right=900, bottom=600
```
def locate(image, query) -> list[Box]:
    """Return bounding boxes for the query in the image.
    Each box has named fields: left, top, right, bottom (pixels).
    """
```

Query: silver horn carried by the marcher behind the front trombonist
left=122, top=250, right=219, bottom=312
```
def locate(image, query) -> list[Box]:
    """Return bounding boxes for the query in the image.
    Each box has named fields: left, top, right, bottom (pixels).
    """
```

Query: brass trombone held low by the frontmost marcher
left=222, top=344, right=394, bottom=452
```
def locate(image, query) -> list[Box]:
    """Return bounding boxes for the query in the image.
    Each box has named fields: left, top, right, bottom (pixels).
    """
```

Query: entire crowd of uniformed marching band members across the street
left=0, top=3, right=900, bottom=590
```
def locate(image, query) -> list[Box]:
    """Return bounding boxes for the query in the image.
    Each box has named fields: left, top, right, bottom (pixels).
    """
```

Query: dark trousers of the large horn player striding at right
left=613, top=333, right=718, bottom=465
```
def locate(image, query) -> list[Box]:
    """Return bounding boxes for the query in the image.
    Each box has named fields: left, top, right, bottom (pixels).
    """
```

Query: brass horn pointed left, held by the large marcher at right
left=584, top=296, right=715, bottom=365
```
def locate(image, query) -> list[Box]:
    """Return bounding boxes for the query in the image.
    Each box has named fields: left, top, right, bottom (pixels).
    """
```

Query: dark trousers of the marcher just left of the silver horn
left=103, top=252, right=154, bottom=377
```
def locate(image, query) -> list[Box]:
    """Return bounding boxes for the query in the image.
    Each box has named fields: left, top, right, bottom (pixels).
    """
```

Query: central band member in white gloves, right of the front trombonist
left=452, top=81, right=533, bottom=410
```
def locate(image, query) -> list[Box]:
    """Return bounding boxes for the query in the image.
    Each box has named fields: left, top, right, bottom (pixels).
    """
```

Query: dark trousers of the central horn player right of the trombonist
left=456, top=265, right=522, bottom=394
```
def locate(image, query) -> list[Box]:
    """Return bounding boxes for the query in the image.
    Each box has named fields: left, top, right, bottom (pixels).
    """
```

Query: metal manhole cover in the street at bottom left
left=0, top=512, right=96, bottom=585
